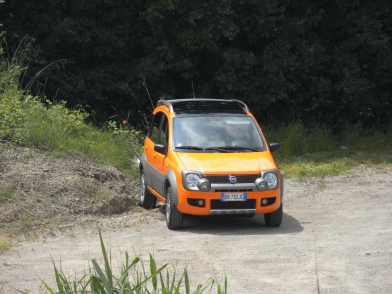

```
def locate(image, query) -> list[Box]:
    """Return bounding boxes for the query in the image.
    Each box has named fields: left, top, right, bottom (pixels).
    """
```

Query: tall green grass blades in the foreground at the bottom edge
left=41, top=231, right=227, bottom=294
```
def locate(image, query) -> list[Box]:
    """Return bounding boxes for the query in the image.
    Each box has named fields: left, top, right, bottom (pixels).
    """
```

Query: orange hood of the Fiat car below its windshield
left=177, top=152, right=275, bottom=173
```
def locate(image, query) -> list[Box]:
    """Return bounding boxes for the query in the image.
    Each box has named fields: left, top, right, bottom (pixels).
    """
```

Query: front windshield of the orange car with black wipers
left=173, top=115, right=265, bottom=152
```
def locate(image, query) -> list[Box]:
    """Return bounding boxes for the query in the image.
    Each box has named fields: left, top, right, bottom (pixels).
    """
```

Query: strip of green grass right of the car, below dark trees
left=264, top=122, right=392, bottom=178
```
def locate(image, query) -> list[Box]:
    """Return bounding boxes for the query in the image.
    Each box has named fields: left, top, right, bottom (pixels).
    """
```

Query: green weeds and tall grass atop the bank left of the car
left=0, top=56, right=141, bottom=178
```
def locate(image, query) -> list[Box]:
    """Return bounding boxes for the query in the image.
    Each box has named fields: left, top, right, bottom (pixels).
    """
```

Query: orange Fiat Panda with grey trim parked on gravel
left=140, top=98, right=283, bottom=230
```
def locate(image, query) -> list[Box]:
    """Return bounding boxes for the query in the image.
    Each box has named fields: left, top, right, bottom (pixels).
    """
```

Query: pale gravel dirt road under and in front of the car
left=0, top=168, right=392, bottom=293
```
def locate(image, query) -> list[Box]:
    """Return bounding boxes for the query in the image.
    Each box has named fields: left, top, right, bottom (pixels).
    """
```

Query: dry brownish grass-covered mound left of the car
left=0, top=142, right=138, bottom=241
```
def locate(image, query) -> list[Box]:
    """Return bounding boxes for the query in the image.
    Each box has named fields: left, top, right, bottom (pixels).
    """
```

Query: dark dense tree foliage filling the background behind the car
left=0, top=0, right=392, bottom=127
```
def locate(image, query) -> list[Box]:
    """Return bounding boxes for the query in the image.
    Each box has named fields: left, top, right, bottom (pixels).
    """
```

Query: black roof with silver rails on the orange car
left=157, top=98, right=249, bottom=115
